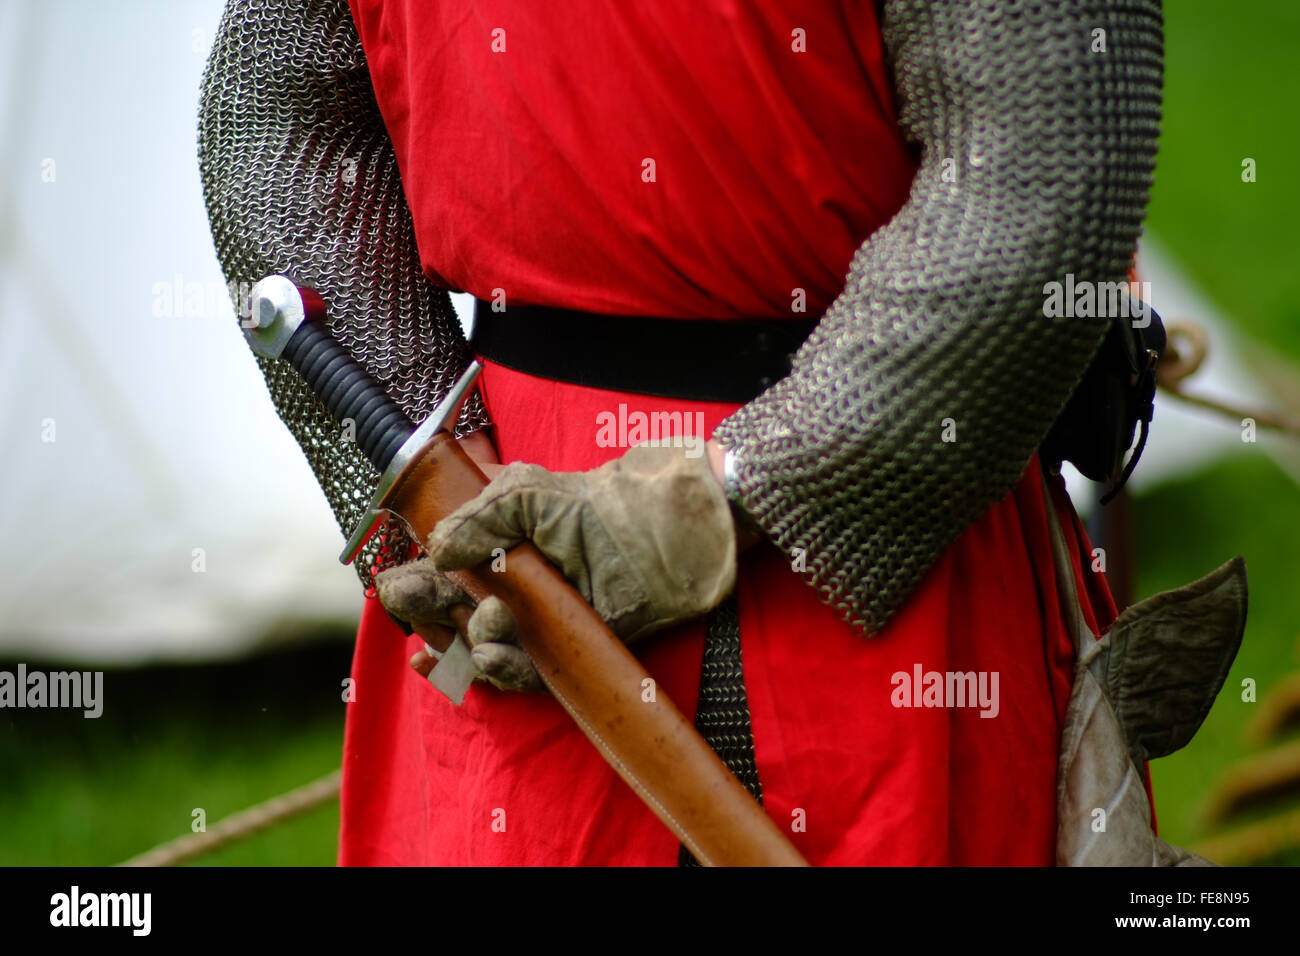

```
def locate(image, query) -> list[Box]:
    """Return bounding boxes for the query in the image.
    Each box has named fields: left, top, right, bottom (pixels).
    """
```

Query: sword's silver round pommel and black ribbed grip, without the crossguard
left=244, top=276, right=415, bottom=475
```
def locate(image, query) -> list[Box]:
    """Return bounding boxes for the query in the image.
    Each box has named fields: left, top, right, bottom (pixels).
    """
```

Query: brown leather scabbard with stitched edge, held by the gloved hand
left=382, top=432, right=807, bottom=866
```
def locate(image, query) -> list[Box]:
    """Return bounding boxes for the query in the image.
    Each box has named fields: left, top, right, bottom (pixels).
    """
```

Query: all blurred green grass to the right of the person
left=1136, top=0, right=1300, bottom=864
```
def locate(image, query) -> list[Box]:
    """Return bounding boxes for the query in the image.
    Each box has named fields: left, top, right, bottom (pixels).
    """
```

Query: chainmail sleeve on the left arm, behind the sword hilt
left=199, top=0, right=486, bottom=587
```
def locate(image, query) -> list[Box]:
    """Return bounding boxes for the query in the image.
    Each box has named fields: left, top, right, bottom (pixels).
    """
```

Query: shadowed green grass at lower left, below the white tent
left=0, top=642, right=351, bottom=866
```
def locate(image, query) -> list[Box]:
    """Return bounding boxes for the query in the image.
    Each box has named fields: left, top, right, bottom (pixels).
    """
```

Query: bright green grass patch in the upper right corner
left=1147, top=0, right=1300, bottom=360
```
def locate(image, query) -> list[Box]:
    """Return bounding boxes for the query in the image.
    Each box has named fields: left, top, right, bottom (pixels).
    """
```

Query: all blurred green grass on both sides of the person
left=0, top=0, right=1300, bottom=865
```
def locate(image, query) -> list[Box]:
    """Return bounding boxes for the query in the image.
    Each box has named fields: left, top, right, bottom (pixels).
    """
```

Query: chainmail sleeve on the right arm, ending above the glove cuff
left=715, top=0, right=1162, bottom=633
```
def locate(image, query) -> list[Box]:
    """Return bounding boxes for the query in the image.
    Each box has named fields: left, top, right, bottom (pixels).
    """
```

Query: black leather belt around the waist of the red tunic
left=469, top=299, right=814, bottom=403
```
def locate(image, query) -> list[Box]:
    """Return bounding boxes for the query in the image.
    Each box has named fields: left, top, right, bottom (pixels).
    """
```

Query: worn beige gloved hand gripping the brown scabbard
left=376, top=445, right=736, bottom=689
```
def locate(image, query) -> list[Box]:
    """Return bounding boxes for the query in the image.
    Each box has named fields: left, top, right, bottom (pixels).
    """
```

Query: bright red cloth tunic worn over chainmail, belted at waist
left=339, top=0, right=1114, bottom=865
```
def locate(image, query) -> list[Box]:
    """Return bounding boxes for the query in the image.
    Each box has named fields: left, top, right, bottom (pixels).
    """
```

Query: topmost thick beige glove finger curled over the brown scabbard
left=428, top=462, right=567, bottom=571
